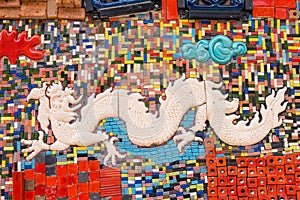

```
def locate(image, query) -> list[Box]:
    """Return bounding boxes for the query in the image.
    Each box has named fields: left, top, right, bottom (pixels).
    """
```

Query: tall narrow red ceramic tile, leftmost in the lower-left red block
left=12, top=172, right=24, bottom=200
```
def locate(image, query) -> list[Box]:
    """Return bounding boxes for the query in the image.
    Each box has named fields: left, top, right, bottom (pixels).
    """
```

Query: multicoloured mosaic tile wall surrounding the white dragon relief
left=0, top=3, right=300, bottom=200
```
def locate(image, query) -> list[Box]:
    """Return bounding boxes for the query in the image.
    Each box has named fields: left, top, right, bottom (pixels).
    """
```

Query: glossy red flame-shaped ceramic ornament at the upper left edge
left=0, top=29, right=44, bottom=64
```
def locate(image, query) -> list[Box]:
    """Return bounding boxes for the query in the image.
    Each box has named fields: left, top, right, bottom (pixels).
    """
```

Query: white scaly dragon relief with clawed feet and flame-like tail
left=21, top=75, right=287, bottom=165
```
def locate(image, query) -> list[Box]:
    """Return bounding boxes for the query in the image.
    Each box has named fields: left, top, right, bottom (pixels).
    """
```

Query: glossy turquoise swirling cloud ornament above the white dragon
left=181, top=35, right=247, bottom=64
